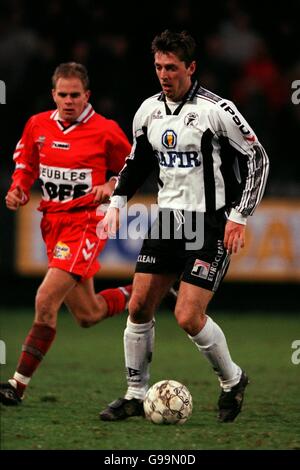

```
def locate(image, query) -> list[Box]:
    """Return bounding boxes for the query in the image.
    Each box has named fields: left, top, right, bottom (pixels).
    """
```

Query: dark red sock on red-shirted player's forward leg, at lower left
left=14, top=323, right=56, bottom=396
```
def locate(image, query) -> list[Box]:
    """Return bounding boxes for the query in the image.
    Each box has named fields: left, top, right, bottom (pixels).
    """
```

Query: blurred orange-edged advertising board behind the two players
left=15, top=195, right=300, bottom=282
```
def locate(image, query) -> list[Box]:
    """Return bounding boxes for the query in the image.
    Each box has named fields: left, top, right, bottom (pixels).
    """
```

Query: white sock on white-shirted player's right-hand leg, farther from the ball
left=189, top=316, right=242, bottom=391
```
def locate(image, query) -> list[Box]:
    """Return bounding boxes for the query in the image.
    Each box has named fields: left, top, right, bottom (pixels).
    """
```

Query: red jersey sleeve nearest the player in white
left=106, top=120, right=131, bottom=173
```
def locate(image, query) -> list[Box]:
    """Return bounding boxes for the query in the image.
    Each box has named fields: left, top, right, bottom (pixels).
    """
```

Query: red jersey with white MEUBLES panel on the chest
left=10, top=104, right=131, bottom=212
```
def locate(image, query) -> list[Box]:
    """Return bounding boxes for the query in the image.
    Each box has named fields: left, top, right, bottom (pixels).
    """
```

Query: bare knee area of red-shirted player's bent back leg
left=64, top=278, right=107, bottom=319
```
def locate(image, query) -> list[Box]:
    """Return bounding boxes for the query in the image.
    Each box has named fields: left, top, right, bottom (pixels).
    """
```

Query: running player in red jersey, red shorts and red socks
left=0, top=62, right=131, bottom=405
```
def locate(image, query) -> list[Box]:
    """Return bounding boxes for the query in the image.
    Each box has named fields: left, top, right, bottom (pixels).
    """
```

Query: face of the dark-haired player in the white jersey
left=154, top=52, right=196, bottom=101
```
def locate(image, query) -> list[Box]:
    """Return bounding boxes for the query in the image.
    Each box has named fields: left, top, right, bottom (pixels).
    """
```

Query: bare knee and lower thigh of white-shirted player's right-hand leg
left=175, top=281, right=214, bottom=329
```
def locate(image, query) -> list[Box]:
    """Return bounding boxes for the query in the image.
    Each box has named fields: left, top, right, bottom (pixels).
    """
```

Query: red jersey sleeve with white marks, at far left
left=9, top=116, right=39, bottom=199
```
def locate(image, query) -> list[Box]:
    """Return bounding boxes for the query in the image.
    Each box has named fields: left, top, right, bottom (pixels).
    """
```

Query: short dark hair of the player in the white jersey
left=151, top=29, right=196, bottom=67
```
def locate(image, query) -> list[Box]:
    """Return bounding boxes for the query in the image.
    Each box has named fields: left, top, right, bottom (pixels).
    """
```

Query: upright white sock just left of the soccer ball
left=124, top=317, right=154, bottom=400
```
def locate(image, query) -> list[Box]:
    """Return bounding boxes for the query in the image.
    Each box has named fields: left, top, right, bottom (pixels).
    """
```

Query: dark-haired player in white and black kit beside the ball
left=100, top=30, right=269, bottom=422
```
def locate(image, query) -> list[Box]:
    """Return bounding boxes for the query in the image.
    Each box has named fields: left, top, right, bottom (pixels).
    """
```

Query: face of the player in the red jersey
left=52, top=77, right=90, bottom=122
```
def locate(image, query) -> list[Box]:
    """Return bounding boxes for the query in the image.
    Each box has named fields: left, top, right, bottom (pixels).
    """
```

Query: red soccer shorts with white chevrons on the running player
left=41, top=209, right=106, bottom=280
